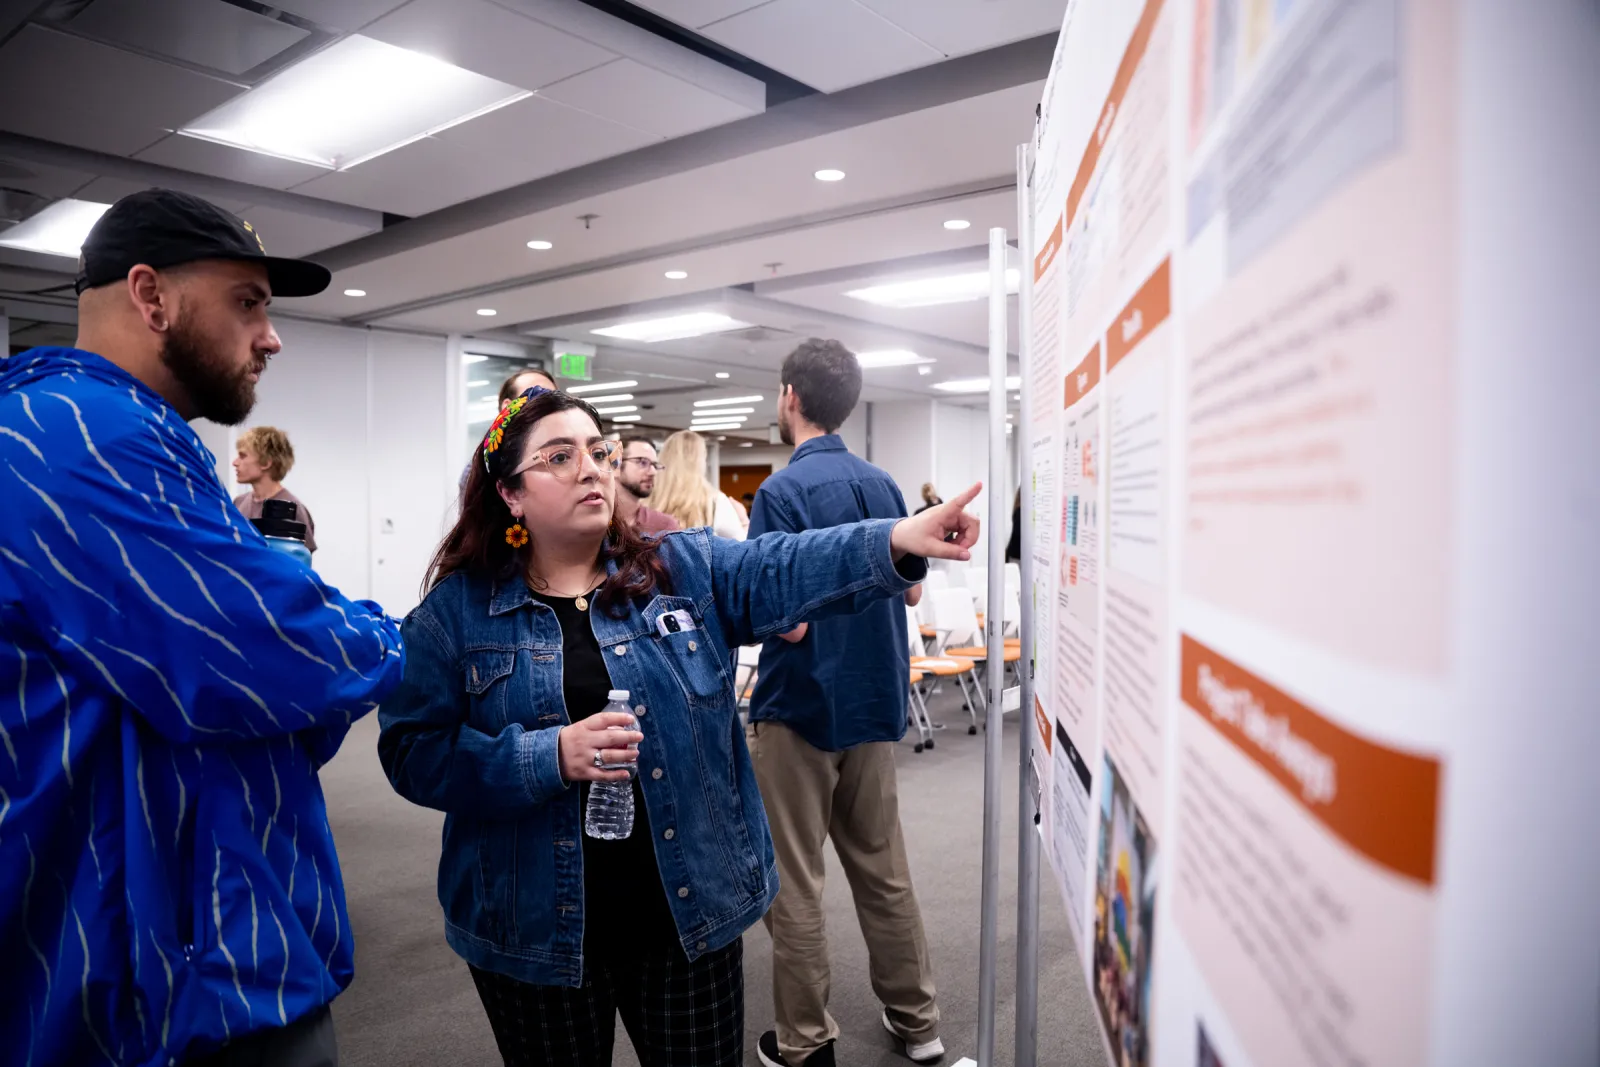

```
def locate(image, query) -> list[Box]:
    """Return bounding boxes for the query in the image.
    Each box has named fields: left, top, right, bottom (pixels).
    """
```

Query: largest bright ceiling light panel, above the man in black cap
left=178, top=34, right=533, bottom=171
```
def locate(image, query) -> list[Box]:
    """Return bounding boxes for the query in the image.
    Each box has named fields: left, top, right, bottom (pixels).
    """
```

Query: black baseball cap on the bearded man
left=77, top=189, right=333, bottom=296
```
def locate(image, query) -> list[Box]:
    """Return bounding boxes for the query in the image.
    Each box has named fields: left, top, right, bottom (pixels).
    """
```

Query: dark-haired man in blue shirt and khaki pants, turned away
left=749, top=339, right=944, bottom=1067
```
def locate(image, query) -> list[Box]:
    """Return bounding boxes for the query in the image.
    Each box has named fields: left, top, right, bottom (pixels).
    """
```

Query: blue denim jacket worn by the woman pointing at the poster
left=378, top=522, right=926, bottom=985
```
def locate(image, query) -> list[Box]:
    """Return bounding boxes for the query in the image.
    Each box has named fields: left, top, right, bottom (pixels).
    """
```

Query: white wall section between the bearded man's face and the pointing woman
left=234, top=318, right=459, bottom=614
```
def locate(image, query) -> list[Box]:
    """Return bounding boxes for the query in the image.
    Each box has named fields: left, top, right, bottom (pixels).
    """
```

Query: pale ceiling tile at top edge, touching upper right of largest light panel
left=363, top=0, right=616, bottom=90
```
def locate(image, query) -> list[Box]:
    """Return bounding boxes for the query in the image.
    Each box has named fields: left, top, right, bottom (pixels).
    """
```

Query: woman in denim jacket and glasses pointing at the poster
left=378, top=389, right=978, bottom=1067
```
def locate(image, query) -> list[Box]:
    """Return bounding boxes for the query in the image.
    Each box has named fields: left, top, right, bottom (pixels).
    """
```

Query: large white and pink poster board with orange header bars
left=1019, top=0, right=1600, bottom=1067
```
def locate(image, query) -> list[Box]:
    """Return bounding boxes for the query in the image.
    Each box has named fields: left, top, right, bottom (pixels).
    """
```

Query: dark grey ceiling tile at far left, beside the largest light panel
left=0, top=26, right=240, bottom=155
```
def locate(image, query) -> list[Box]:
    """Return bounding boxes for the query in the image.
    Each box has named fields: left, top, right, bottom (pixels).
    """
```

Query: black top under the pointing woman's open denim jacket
left=534, top=593, right=682, bottom=955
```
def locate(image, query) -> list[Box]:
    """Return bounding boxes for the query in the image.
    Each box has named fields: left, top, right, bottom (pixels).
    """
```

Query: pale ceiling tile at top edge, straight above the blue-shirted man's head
left=701, top=0, right=944, bottom=93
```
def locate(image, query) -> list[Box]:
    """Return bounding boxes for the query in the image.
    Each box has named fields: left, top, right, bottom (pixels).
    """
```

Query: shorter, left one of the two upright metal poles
left=978, top=226, right=1006, bottom=1067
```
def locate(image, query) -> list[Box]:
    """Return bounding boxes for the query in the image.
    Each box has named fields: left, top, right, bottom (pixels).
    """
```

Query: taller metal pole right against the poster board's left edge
left=1013, top=142, right=1045, bottom=1067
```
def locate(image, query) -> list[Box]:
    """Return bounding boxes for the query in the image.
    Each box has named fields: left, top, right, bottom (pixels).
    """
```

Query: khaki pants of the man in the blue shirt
left=747, top=721, right=939, bottom=1064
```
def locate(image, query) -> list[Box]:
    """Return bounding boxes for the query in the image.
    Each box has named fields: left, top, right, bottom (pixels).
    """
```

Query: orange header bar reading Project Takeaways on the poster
left=1182, top=633, right=1440, bottom=885
